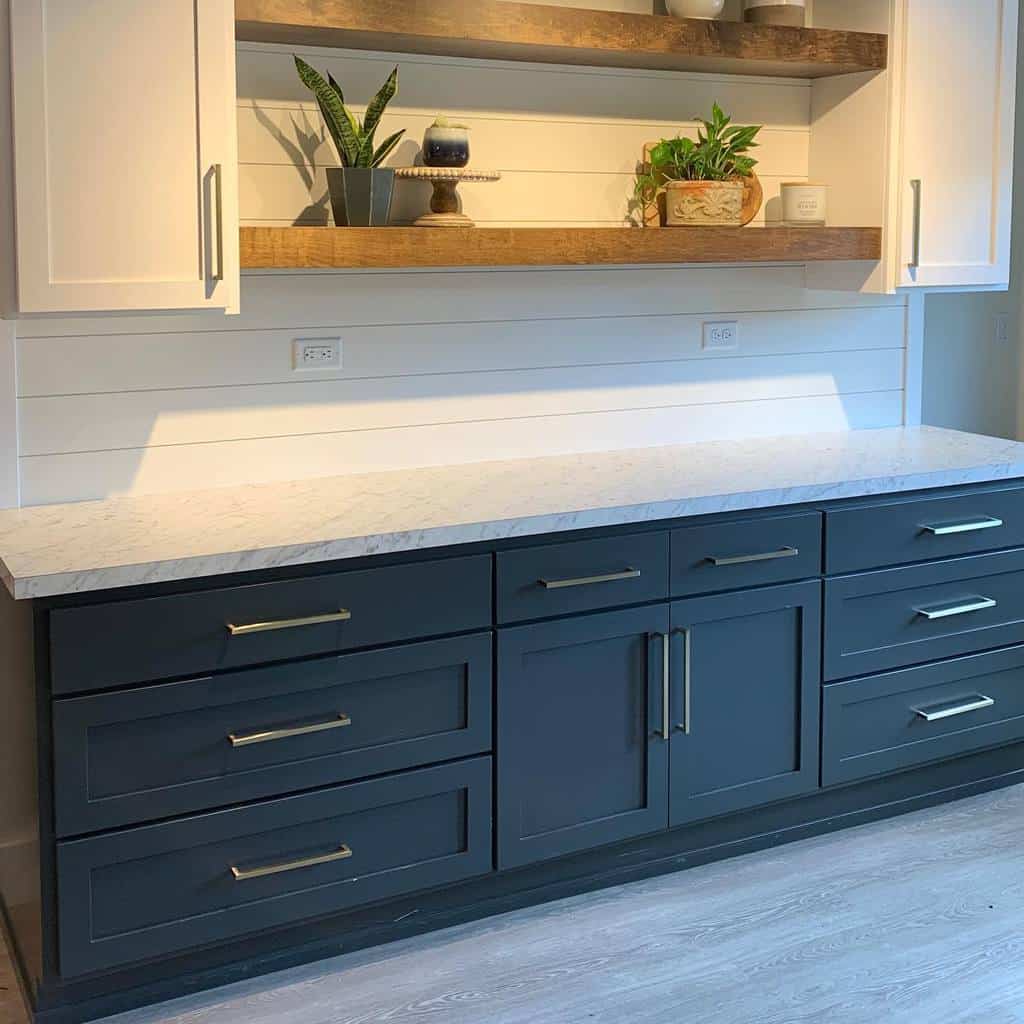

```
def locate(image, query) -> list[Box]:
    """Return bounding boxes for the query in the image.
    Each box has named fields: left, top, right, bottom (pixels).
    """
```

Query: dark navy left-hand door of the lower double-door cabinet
left=498, top=604, right=669, bottom=868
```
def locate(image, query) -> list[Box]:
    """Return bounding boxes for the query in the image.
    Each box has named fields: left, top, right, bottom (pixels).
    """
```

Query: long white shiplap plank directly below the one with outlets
left=20, top=349, right=903, bottom=456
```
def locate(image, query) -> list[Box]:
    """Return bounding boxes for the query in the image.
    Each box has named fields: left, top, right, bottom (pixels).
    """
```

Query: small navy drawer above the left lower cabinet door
left=497, top=534, right=669, bottom=623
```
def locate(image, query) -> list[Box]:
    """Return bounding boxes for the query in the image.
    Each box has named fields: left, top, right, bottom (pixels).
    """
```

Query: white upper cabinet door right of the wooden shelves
left=898, top=0, right=1018, bottom=288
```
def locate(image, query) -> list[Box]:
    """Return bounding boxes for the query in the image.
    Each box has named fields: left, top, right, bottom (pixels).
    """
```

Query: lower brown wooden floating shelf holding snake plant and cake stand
left=242, top=227, right=882, bottom=269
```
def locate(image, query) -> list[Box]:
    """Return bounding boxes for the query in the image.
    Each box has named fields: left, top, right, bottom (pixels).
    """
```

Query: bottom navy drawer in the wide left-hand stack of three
left=57, top=758, right=492, bottom=978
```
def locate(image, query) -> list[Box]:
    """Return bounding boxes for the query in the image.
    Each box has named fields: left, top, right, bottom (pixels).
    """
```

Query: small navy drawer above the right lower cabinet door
left=671, top=512, right=821, bottom=597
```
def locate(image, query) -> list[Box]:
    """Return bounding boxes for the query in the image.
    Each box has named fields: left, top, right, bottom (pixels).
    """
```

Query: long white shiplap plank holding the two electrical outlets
left=17, top=306, right=905, bottom=397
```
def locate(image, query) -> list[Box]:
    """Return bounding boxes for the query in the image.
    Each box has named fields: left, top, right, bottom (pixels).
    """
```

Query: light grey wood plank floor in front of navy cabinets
left=6, top=786, right=1024, bottom=1024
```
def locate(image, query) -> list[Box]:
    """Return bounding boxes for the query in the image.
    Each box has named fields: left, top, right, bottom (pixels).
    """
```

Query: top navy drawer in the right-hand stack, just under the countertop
left=825, top=487, right=1024, bottom=573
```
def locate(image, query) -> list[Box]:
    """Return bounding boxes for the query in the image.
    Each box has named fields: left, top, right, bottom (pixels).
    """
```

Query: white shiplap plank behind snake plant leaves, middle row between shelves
left=238, top=100, right=810, bottom=178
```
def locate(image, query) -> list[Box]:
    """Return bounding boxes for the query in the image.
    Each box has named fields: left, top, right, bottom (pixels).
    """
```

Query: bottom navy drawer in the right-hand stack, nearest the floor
left=821, top=646, right=1024, bottom=785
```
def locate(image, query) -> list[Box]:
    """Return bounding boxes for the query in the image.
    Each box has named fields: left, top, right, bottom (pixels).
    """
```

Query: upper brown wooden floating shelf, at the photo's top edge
left=234, top=0, right=888, bottom=78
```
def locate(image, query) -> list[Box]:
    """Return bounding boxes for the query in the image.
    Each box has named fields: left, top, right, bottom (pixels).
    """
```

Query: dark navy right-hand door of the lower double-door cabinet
left=669, top=582, right=821, bottom=826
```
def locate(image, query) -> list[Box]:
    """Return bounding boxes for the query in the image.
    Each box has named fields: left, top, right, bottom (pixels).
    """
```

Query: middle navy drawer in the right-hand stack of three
left=825, top=550, right=1024, bottom=679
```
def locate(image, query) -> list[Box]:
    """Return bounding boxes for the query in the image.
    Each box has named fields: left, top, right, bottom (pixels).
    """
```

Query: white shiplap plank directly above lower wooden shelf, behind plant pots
left=239, top=164, right=790, bottom=230
